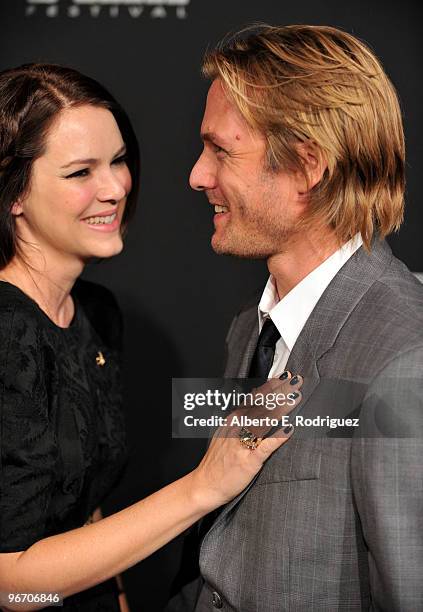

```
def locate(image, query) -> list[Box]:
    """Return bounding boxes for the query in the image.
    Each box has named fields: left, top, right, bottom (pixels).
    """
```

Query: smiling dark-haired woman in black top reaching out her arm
left=0, top=64, right=301, bottom=612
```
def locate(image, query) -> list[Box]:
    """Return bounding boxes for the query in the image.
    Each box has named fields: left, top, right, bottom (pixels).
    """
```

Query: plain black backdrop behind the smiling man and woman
left=0, top=0, right=423, bottom=612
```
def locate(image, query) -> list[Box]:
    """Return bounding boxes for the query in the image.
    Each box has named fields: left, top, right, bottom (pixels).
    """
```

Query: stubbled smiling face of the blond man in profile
left=190, top=80, right=305, bottom=258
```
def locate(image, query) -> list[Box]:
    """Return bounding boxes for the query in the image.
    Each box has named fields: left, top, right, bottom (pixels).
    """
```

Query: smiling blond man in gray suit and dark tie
left=172, top=26, right=423, bottom=612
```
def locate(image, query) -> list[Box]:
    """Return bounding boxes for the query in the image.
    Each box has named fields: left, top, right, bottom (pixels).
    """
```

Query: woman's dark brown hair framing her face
left=0, top=64, right=140, bottom=270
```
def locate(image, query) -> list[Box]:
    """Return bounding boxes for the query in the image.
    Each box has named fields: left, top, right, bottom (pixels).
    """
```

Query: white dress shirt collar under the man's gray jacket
left=258, top=234, right=363, bottom=378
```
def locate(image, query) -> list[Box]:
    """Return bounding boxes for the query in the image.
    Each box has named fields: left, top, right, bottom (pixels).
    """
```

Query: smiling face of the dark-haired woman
left=13, top=105, right=131, bottom=265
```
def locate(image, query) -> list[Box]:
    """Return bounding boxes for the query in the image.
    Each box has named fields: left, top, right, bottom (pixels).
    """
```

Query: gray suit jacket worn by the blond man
left=169, top=241, right=423, bottom=612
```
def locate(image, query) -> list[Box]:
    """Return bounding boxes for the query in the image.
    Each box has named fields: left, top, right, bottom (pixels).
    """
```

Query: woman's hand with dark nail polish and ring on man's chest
left=191, top=372, right=303, bottom=511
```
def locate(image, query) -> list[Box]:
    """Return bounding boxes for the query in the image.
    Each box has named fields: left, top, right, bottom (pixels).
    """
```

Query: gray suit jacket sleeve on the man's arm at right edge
left=351, top=347, right=423, bottom=612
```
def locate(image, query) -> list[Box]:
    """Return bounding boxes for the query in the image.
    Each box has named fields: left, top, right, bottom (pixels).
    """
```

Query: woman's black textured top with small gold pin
left=0, top=281, right=126, bottom=612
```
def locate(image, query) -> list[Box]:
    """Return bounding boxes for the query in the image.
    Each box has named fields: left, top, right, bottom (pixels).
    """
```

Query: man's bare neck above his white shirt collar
left=267, top=229, right=342, bottom=299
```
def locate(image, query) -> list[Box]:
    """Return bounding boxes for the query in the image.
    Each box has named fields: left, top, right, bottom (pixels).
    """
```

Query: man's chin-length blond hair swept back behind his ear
left=203, top=25, right=405, bottom=248
